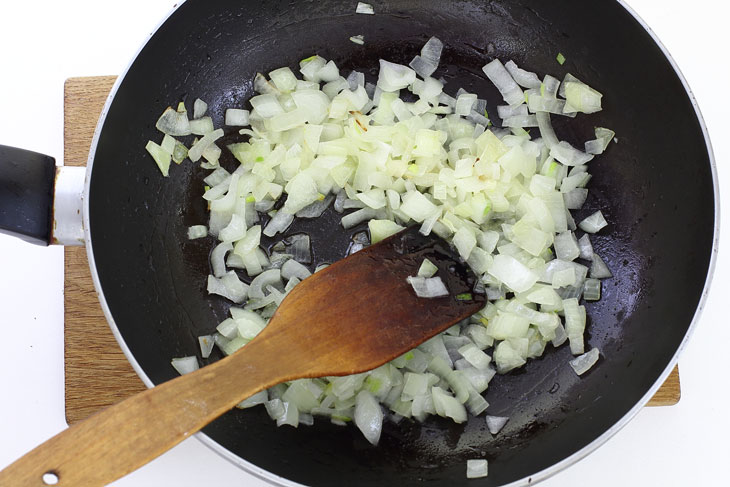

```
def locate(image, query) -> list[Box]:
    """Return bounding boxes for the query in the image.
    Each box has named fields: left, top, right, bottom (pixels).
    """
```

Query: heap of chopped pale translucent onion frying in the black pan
left=150, top=40, right=615, bottom=452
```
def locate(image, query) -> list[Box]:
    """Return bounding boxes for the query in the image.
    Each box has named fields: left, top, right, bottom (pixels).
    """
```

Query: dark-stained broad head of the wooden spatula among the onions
left=256, top=227, right=486, bottom=377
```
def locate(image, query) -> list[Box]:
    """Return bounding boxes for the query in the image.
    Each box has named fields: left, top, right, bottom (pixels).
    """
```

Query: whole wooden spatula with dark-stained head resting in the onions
left=0, top=227, right=486, bottom=487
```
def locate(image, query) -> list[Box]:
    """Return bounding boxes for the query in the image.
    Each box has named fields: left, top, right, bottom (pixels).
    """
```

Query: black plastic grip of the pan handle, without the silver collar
left=0, top=145, right=56, bottom=245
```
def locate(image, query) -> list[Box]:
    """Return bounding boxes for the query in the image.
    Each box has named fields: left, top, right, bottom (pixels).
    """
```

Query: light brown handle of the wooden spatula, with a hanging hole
left=0, top=340, right=283, bottom=487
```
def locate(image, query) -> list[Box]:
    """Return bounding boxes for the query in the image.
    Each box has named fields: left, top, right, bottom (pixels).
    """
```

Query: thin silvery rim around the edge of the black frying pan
left=78, top=0, right=720, bottom=487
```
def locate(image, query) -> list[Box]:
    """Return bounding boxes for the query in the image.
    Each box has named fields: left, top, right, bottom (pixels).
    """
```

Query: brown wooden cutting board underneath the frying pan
left=64, top=76, right=680, bottom=424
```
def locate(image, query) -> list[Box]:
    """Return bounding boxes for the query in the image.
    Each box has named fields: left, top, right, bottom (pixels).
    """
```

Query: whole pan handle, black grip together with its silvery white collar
left=0, top=145, right=86, bottom=245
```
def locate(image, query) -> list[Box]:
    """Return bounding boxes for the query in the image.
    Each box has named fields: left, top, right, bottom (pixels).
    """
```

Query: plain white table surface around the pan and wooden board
left=0, top=0, right=730, bottom=487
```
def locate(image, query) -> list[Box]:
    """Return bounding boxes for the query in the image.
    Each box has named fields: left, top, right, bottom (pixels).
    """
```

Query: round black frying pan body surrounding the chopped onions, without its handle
left=0, top=0, right=715, bottom=486
